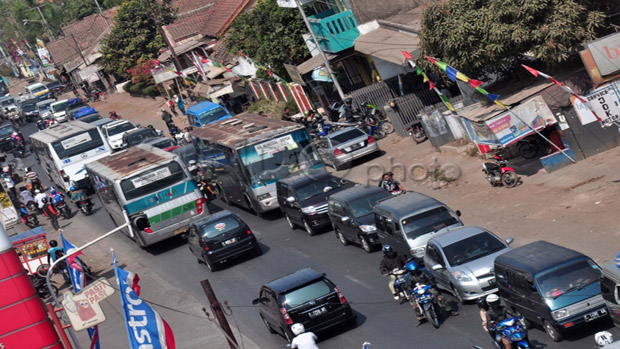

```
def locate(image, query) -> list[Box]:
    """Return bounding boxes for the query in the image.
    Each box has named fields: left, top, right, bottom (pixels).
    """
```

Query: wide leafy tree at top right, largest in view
left=420, top=0, right=617, bottom=78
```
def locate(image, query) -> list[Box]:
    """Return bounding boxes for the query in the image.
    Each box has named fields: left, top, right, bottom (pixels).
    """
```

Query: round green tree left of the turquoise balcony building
left=224, top=0, right=310, bottom=78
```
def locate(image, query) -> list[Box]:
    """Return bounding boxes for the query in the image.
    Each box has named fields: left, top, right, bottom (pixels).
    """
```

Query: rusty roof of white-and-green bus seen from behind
left=86, top=144, right=177, bottom=180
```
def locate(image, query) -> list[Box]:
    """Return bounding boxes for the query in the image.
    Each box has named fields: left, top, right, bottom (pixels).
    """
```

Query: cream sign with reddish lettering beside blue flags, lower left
left=62, top=278, right=114, bottom=331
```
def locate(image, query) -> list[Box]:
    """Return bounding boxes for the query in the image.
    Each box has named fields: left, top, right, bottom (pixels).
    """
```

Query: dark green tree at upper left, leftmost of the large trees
left=102, top=0, right=174, bottom=77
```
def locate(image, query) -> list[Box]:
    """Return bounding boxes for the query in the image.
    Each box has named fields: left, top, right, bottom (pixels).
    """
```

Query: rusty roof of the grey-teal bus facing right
left=192, top=113, right=303, bottom=149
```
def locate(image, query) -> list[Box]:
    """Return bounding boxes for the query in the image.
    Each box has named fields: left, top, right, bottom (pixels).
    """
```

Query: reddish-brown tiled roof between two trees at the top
left=164, top=0, right=250, bottom=43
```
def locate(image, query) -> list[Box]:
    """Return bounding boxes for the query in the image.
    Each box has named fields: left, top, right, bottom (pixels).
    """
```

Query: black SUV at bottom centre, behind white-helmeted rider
left=252, top=268, right=357, bottom=343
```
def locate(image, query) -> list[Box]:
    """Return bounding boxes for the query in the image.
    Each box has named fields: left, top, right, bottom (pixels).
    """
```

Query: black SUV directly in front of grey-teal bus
left=276, top=170, right=353, bottom=236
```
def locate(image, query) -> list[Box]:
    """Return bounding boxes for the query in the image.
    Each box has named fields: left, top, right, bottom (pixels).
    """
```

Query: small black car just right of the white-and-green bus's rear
left=187, top=210, right=262, bottom=271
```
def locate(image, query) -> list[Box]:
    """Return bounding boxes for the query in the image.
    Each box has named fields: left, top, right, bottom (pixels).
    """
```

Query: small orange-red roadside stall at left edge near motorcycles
left=9, top=227, right=49, bottom=274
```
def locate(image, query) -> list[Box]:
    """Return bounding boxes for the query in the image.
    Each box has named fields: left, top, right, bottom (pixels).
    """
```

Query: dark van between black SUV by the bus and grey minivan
left=328, top=185, right=392, bottom=253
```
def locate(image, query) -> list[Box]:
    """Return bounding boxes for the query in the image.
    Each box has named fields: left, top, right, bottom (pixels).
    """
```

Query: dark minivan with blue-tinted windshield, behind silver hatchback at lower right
left=494, top=241, right=608, bottom=342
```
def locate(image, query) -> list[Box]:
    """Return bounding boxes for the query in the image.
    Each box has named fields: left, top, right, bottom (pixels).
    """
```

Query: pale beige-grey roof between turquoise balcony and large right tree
left=355, top=27, right=420, bottom=65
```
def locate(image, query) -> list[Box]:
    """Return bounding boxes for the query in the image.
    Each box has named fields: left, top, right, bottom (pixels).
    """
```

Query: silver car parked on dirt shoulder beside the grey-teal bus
left=316, top=127, right=379, bottom=170
